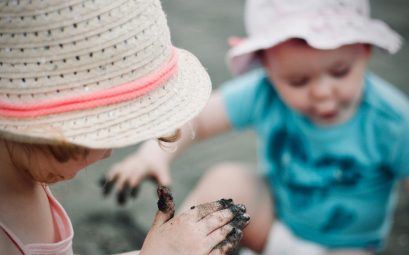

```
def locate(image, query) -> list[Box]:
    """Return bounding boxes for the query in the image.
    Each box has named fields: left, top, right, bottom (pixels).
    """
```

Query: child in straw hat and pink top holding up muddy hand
left=0, top=0, right=249, bottom=255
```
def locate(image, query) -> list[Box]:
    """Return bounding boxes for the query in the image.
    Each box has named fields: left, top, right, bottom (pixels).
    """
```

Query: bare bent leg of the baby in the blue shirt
left=180, top=163, right=274, bottom=252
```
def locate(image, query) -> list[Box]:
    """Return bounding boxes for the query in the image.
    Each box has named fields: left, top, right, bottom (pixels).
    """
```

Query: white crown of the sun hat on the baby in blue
left=245, top=0, right=369, bottom=36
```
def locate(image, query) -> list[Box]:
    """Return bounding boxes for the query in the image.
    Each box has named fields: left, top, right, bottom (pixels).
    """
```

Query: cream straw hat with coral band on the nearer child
left=0, top=0, right=211, bottom=148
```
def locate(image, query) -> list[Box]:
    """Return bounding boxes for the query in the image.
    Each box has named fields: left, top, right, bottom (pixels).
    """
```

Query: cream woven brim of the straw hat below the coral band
left=0, top=49, right=211, bottom=148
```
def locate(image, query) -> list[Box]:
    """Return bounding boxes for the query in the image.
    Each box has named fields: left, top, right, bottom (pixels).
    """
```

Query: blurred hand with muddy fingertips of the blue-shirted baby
left=100, top=141, right=171, bottom=205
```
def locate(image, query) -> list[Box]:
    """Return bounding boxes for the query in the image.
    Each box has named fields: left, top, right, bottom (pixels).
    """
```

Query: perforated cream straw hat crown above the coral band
left=0, top=0, right=172, bottom=103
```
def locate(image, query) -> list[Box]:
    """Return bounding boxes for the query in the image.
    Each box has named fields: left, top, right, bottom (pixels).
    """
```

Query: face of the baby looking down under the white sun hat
left=262, top=39, right=371, bottom=125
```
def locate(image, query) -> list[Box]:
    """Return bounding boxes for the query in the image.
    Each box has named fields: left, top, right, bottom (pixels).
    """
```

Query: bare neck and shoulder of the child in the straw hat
left=0, top=145, right=57, bottom=243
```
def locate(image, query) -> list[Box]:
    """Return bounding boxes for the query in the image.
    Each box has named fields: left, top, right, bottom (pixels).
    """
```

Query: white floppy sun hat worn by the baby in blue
left=227, top=0, right=401, bottom=74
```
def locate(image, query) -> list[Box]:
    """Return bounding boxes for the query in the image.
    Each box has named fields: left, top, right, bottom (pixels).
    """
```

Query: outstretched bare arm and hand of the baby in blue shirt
left=102, top=92, right=231, bottom=195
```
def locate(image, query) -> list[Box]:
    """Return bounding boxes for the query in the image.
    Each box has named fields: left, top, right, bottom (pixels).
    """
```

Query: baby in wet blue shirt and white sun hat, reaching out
left=103, top=0, right=409, bottom=255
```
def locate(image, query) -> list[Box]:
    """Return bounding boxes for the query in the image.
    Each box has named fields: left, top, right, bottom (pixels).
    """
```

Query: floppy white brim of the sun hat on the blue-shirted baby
left=227, top=16, right=402, bottom=75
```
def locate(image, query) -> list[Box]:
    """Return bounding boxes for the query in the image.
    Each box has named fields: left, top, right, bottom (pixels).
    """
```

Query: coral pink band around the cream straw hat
left=0, top=48, right=177, bottom=118
